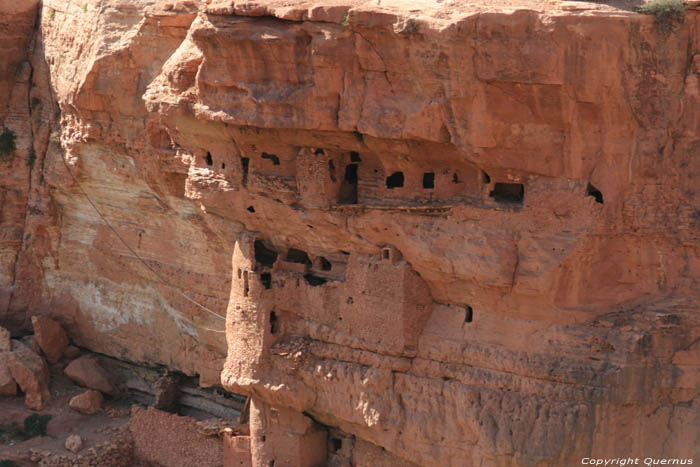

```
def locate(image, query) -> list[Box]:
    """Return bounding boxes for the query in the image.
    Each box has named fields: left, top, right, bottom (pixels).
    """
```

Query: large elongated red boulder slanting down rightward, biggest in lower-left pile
left=7, top=339, right=51, bottom=410
